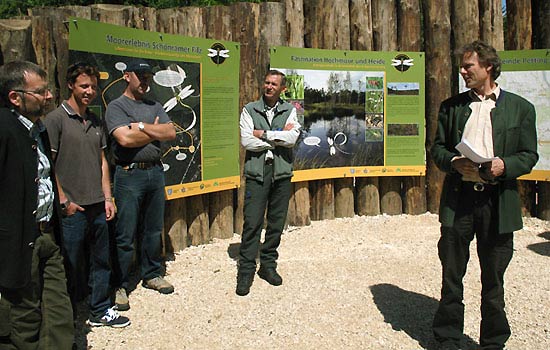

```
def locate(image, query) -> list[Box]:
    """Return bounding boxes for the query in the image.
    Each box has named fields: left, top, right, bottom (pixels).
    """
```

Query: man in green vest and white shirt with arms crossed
left=236, top=70, right=300, bottom=296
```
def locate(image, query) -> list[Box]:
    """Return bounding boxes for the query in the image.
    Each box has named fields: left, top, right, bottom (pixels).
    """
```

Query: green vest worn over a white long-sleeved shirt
left=244, top=99, right=294, bottom=182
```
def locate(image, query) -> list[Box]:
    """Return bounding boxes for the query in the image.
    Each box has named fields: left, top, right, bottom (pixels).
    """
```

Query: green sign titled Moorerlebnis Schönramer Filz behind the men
left=69, top=18, right=240, bottom=199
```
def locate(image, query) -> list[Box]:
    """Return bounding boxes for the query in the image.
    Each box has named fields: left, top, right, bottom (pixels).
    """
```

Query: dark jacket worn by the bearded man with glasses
left=0, top=108, right=62, bottom=290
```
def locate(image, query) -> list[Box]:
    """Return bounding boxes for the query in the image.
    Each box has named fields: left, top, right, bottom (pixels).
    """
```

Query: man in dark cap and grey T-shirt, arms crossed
left=105, top=60, right=176, bottom=310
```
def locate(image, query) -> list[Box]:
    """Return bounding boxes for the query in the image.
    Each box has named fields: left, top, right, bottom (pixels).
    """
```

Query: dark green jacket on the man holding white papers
left=431, top=90, right=538, bottom=233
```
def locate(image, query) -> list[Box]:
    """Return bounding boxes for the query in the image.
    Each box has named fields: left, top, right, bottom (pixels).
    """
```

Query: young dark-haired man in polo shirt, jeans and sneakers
left=44, top=63, right=130, bottom=328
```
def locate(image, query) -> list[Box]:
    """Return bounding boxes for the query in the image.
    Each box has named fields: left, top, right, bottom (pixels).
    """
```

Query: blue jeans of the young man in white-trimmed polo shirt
left=62, top=202, right=111, bottom=317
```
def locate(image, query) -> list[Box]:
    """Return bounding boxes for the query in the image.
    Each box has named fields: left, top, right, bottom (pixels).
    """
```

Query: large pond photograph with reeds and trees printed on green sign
left=279, top=69, right=384, bottom=170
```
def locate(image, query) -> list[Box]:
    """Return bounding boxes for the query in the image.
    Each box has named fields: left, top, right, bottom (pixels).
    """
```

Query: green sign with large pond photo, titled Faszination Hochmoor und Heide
left=270, top=46, right=426, bottom=181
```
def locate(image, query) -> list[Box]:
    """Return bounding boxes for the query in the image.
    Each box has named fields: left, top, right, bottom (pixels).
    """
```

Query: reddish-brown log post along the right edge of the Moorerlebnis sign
left=230, top=2, right=265, bottom=234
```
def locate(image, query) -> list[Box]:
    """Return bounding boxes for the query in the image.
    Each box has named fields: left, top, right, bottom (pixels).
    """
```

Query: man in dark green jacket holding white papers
left=431, top=41, right=538, bottom=349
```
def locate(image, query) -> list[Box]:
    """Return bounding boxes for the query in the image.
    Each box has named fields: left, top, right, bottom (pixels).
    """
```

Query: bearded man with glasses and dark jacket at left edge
left=0, top=62, right=74, bottom=349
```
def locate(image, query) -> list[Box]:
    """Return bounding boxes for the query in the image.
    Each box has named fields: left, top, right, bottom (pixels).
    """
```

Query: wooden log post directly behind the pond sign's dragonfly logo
left=397, top=0, right=427, bottom=215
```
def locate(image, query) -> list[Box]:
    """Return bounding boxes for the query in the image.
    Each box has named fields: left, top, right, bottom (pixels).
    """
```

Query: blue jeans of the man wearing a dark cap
left=114, top=165, right=164, bottom=289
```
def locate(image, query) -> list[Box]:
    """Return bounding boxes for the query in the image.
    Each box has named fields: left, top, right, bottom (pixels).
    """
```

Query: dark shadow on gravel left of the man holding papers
left=370, top=284, right=476, bottom=350
